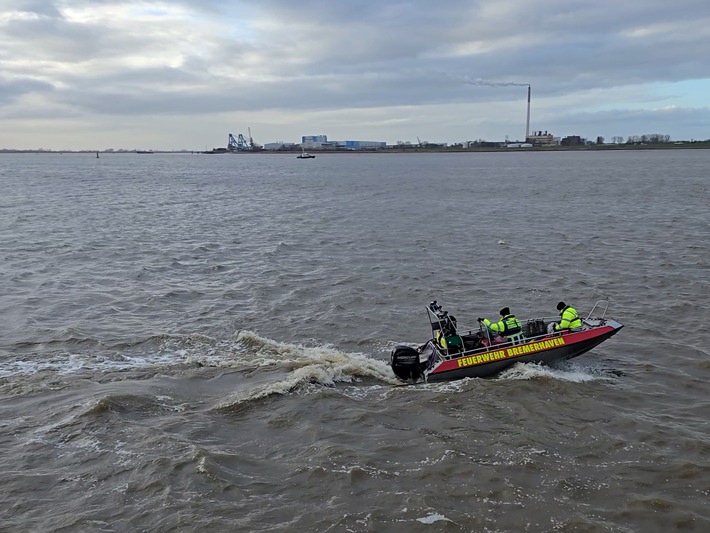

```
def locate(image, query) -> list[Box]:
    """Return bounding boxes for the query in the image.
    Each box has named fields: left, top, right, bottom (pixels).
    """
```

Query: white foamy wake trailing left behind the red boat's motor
left=0, top=330, right=398, bottom=396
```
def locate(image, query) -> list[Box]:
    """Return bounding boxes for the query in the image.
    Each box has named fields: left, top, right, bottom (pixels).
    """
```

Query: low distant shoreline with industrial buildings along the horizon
left=0, top=140, right=710, bottom=156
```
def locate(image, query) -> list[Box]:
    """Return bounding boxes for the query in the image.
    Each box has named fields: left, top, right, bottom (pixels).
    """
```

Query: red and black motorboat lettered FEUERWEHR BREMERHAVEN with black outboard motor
left=390, top=300, right=624, bottom=383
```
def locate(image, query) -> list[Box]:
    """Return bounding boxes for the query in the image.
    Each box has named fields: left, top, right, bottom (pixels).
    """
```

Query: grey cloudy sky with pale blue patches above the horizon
left=0, top=0, right=710, bottom=150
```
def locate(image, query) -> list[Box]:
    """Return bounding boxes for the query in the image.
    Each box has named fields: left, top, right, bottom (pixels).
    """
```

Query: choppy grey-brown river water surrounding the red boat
left=0, top=150, right=710, bottom=532
